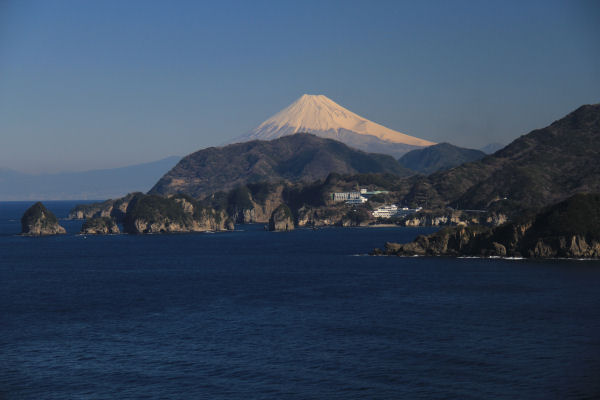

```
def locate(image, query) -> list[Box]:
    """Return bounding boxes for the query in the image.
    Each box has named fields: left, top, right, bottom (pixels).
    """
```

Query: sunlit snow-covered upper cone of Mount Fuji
left=243, top=94, right=435, bottom=147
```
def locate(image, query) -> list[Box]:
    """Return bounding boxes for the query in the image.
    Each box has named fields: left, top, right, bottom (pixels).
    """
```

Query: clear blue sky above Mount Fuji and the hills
left=0, top=0, right=600, bottom=172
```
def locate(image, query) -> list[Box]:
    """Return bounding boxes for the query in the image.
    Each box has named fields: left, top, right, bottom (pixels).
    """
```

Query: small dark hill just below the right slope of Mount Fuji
left=398, top=143, right=485, bottom=175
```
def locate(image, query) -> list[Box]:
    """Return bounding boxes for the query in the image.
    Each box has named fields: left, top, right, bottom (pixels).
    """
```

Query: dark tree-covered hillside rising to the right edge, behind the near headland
left=414, top=104, right=600, bottom=209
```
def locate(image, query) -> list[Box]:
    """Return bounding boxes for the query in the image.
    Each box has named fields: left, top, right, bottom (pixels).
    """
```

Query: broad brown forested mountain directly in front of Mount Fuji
left=150, top=133, right=412, bottom=197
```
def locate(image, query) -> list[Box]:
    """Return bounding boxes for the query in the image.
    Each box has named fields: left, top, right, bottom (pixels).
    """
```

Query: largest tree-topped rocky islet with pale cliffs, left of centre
left=123, top=194, right=233, bottom=234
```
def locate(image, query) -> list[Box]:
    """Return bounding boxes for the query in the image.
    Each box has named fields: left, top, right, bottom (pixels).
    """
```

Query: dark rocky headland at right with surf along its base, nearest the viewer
left=372, top=194, right=600, bottom=258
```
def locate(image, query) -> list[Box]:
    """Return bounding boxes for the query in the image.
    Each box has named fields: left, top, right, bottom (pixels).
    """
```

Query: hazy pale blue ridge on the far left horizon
left=0, top=156, right=181, bottom=201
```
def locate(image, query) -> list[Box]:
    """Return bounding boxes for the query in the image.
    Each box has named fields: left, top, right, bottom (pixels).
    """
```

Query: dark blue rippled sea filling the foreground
left=0, top=202, right=600, bottom=400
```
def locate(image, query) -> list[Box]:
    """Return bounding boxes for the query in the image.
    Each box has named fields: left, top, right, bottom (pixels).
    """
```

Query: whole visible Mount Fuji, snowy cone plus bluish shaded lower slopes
left=230, top=94, right=436, bottom=158
